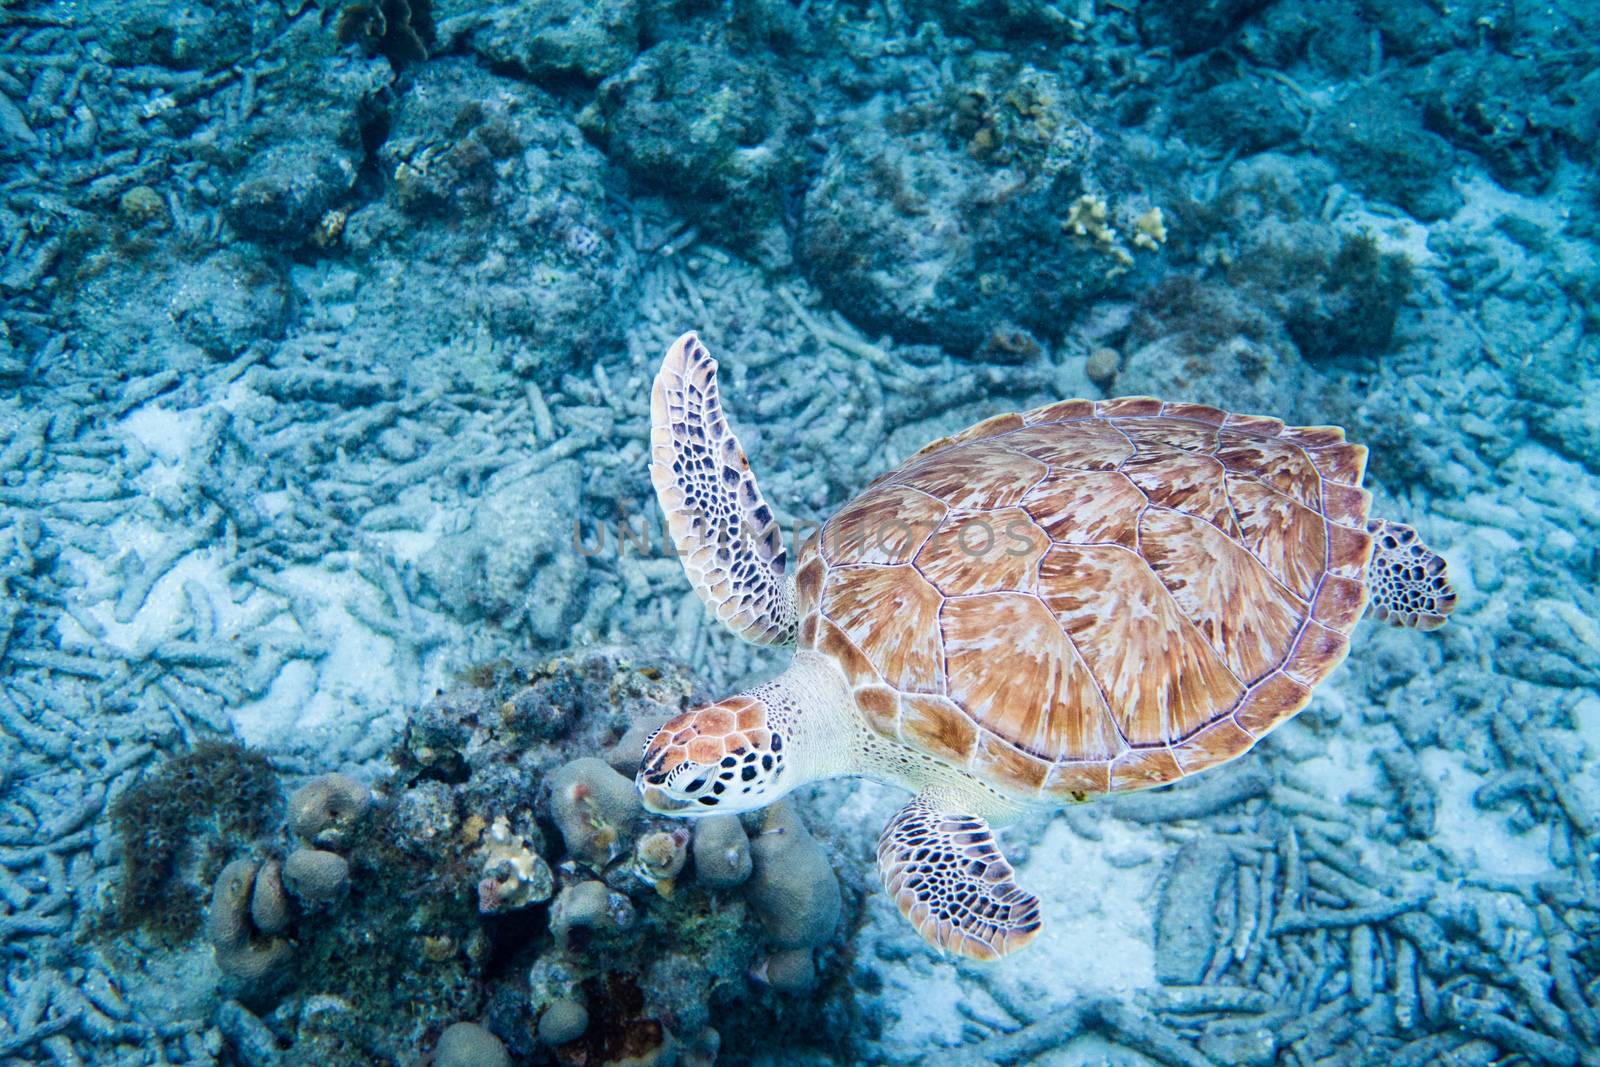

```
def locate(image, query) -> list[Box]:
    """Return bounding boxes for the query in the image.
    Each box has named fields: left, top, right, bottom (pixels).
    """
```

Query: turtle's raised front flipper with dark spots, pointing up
left=650, top=331, right=798, bottom=645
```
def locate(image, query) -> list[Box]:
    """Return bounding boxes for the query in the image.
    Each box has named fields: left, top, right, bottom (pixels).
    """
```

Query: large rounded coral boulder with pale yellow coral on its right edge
left=800, top=58, right=1149, bottom=352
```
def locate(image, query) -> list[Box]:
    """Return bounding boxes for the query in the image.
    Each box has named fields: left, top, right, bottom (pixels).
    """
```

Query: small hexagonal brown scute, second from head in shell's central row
left=917, top=507, right=1050, bottom=597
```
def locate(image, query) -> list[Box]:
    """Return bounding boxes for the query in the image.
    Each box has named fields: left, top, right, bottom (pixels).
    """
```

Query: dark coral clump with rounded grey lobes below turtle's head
left=112, top=649, right=859, bottom=1067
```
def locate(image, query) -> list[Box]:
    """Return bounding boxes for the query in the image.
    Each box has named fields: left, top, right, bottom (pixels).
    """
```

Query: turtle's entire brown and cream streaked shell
left=795, top=397, right=1373, bottom=801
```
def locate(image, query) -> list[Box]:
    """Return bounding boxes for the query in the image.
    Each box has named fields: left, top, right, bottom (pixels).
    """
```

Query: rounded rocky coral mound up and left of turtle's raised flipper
left=342, top=59, right=627, bottom=388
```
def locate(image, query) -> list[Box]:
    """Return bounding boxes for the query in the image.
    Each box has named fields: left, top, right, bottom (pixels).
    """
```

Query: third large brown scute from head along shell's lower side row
left=1038, top=545, right=1245, bottom=745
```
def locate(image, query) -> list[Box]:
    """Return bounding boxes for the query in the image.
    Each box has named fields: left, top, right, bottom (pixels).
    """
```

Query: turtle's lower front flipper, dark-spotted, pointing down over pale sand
left=878, top=795, right=1038, bottom=960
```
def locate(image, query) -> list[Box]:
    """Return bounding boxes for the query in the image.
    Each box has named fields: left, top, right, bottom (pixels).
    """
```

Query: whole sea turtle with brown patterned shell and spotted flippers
left=637, top=333, right=1454, bottom=960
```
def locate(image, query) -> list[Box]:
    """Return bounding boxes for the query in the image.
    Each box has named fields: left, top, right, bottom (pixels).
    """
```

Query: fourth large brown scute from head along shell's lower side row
left=1139, top=507, right=1306, bottom=683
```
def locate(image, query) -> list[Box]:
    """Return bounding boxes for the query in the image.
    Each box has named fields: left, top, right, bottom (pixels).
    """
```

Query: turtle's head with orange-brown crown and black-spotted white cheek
left=635, top=696, right=786, bottom=816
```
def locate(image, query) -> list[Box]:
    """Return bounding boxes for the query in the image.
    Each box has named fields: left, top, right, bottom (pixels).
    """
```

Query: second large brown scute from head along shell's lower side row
left=939, top=593, right=1118, bottom=760
